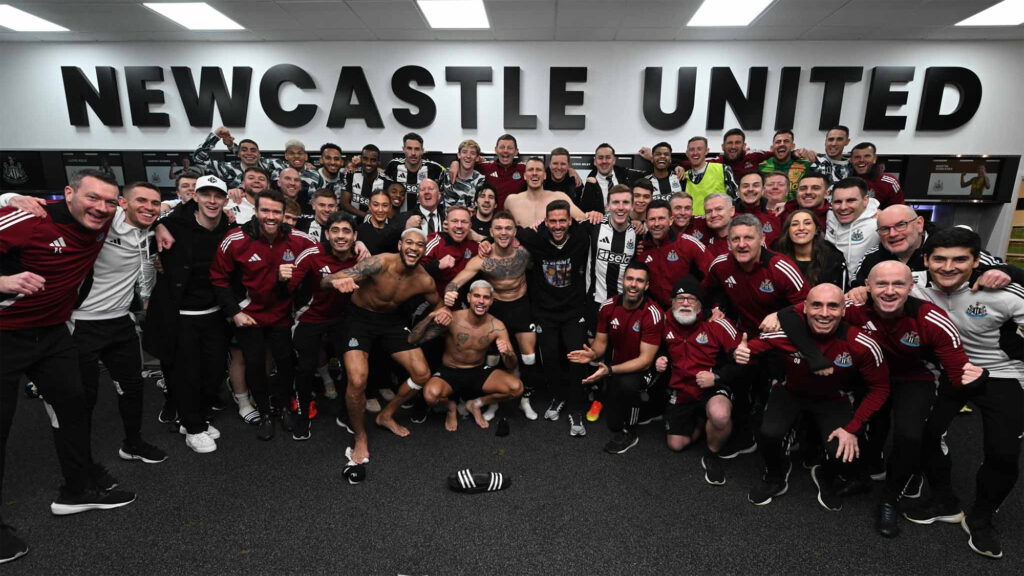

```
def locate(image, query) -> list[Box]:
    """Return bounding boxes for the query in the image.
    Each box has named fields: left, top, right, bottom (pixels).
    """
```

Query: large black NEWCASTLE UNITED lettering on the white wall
left=60, top=64, right=982, bottom=131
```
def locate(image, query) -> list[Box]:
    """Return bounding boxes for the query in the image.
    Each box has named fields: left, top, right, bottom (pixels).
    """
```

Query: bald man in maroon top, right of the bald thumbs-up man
left=778, top=260, right=983, bottom=538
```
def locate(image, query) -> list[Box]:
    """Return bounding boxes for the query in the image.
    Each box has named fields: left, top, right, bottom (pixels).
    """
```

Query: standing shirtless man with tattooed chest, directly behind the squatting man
left=444, top=210, right=537, bottom=420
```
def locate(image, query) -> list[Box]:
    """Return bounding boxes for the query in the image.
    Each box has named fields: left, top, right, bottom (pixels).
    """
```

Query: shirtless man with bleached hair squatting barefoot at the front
left=409, top=280, right=522, bottom=431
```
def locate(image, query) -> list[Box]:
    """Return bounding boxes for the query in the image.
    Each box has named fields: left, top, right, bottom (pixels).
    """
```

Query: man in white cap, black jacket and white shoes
left=142, top=176, right=230, bottom=454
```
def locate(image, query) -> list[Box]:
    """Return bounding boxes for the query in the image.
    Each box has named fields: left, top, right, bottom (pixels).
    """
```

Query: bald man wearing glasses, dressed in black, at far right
left=846, top=204, right=1024, bottom=295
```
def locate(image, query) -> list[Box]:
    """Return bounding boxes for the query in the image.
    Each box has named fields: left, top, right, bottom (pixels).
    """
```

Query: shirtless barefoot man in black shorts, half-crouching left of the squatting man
left=322, top=228, right=452, bottom=462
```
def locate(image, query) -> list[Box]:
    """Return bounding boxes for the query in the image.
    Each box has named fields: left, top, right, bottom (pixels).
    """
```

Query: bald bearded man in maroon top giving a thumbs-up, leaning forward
left=734, top=284, right=889, bottom=510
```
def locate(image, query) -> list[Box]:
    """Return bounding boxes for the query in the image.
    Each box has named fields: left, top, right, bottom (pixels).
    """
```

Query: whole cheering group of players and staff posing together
left=0, top=126, right=1024, bottom=562
